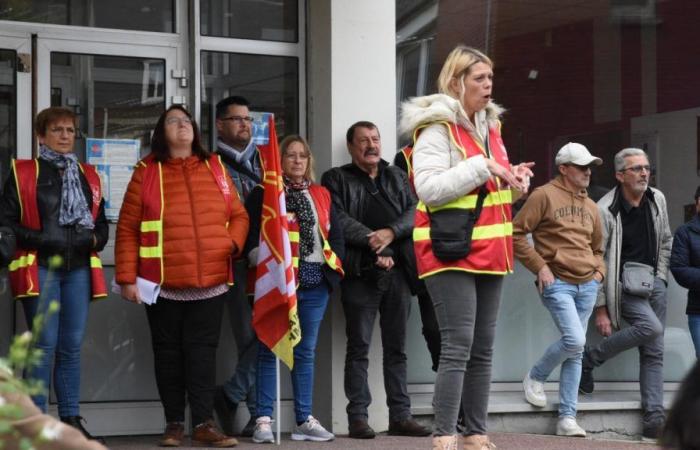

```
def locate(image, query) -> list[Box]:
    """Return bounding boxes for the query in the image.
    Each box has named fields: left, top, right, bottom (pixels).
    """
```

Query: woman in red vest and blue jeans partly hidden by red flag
left=246, top=135, right=345, bottom=443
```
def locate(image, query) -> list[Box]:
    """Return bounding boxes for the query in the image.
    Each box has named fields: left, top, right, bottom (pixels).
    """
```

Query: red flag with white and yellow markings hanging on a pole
left=253, top=114, right=301, bottom=369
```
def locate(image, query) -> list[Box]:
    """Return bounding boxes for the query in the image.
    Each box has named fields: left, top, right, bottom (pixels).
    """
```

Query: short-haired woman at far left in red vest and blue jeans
left=1, top=107, right=108, bottom=439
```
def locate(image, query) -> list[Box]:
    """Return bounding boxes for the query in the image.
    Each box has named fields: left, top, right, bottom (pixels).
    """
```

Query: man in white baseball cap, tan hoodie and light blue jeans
left=513, top=142, right=605, bottom=437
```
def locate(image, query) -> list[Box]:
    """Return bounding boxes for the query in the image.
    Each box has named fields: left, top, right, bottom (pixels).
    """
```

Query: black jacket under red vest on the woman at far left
left=0, top=159, right=109, bottom=270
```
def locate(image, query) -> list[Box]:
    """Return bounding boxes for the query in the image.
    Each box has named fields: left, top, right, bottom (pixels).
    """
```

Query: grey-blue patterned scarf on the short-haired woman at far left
left=39, top=145, right=95, bottom=230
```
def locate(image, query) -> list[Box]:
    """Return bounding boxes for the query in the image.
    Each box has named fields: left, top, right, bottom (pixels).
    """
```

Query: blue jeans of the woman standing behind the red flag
left=257, top=283, right=328, bottom=423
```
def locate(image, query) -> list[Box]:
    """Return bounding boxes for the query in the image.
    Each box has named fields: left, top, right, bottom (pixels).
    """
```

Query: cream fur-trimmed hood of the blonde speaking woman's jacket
left=399, top=94, right=505, bottom=137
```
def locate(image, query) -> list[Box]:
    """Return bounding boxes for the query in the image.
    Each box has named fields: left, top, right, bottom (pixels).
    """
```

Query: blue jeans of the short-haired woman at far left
left=22, top=266, right=91, bottom=417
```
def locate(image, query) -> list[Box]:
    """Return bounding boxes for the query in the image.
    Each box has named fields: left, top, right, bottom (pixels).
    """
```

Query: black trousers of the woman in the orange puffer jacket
left=146, top=294, right=226, bottom=426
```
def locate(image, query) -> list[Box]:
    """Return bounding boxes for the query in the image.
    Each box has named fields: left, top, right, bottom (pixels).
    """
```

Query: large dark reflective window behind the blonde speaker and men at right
left=396, top=0, right=700, bottom=381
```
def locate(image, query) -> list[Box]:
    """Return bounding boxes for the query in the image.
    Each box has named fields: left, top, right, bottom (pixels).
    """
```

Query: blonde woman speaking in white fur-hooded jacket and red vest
left=401, top=46, right=533, bottom=450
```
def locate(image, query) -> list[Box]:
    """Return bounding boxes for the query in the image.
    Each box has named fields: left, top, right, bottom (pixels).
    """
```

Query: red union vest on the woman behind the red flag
left=287, top=184, right=345, bottom=286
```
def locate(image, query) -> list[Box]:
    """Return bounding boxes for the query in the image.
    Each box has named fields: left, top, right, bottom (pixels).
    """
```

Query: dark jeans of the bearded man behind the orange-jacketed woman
left=224, top=264, right=258, bottom=417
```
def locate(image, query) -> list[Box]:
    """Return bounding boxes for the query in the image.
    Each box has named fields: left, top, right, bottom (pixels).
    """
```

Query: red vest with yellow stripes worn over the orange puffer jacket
left=136, top=155, right=233, bottom=284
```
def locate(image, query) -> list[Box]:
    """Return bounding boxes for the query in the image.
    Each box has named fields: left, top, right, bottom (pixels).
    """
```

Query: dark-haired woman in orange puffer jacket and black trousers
left=115, top=105, right=248, bottom=447
